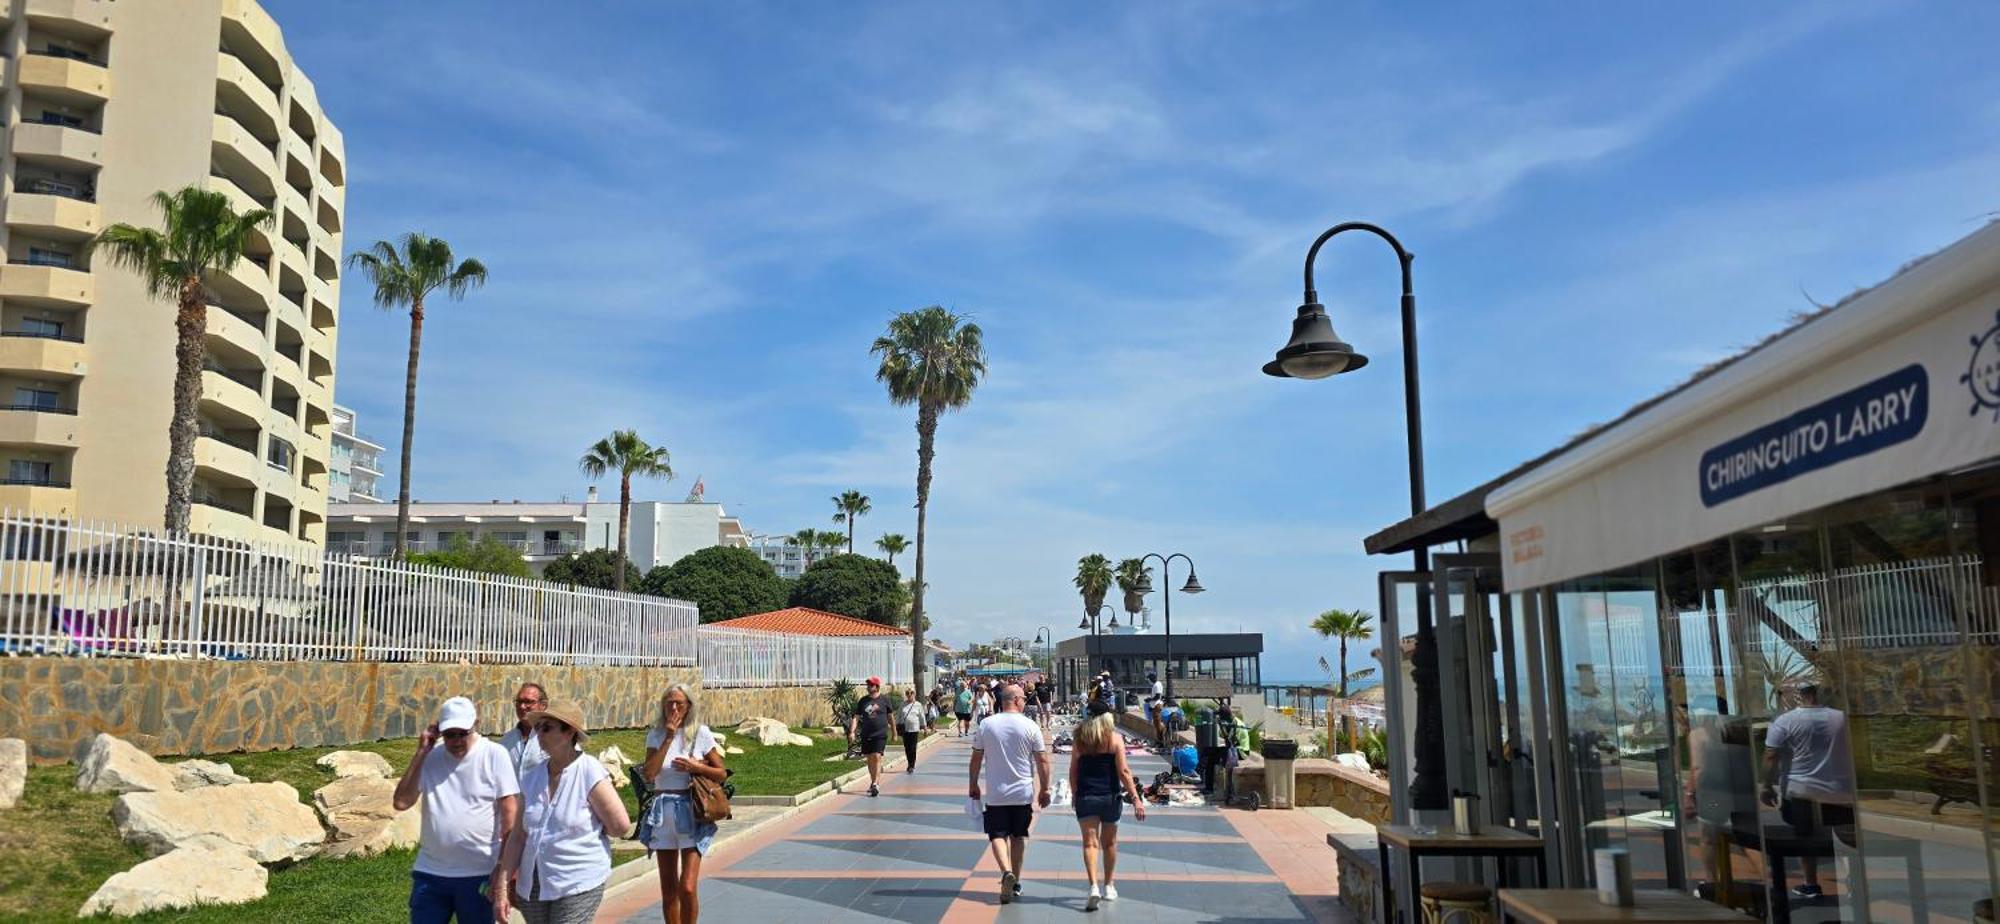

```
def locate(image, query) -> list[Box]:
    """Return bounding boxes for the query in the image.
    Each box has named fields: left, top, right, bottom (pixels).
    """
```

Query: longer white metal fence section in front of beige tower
left=0, top=510, right=698, bottom=664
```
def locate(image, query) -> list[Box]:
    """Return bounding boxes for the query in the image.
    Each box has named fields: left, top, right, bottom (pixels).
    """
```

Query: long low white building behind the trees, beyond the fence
left=326, top=488, right=750, bottom=574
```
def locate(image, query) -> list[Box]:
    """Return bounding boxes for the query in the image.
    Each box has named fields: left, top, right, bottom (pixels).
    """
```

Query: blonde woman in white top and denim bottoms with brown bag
left=642, top=684, right=728, bottom=924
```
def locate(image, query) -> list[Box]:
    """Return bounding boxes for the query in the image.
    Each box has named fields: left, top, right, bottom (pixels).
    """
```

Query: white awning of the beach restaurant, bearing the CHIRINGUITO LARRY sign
left=1486, top=224, right=2000, bottom=590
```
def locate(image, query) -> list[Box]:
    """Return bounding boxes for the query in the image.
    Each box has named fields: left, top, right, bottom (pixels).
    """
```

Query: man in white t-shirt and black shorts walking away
left=966, top=684, right=1052, bottom=904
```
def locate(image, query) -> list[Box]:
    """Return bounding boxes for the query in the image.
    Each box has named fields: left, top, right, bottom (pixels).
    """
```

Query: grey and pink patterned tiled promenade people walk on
left=598, top=738, right=1352, bottom=924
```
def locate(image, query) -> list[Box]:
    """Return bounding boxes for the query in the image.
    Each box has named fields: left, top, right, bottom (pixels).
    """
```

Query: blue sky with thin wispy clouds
left=268, top=0, right=2000, bottom=676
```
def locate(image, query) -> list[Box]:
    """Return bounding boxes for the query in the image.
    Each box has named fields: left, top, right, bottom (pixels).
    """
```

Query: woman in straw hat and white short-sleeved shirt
left=488, top=702, right=632, bottom=924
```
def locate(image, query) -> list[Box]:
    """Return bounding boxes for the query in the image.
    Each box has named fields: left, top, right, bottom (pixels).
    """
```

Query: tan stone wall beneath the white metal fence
left=0, top=658, right=704, bottom=764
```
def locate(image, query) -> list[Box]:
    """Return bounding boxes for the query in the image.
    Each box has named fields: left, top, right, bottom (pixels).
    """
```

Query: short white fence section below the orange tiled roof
left=700, top=626, right=910, bottom=686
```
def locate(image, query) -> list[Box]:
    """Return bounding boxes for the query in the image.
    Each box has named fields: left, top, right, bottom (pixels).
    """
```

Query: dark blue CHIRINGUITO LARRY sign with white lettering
left=1702, top=364, right=1930, bottom=506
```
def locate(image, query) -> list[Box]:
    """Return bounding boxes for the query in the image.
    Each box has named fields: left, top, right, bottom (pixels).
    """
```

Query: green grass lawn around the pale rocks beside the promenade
left=0, top=728, right=862, bottom=922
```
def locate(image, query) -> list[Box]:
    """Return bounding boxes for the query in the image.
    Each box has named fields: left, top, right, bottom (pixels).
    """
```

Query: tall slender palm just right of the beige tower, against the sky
left=348, top=232, right=488, bottom=560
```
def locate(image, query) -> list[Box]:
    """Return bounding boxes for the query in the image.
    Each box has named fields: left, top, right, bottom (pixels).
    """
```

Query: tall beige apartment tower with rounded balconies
left=0, top=0, right=346, bottom=542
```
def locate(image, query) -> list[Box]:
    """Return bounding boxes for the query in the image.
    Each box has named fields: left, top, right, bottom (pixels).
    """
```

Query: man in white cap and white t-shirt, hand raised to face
left=392, top=696, right=520, bottom=924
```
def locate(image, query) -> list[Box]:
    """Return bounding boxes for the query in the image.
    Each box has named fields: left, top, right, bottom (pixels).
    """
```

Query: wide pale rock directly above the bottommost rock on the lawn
left=112, top=782, right=326, bottom=864
